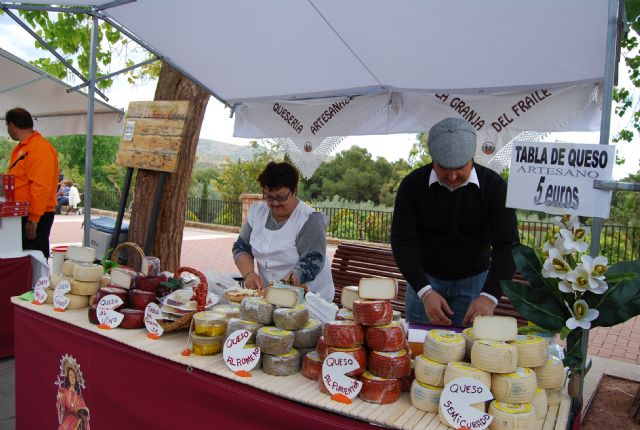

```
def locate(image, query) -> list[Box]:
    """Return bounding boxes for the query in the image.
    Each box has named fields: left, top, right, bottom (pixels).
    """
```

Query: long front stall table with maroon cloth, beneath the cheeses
left=12, top=297, right=570, bottom=430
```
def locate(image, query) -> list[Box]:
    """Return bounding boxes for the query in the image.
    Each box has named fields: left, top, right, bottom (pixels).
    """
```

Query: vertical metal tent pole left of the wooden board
left=83, top=16, right=98, bottom=246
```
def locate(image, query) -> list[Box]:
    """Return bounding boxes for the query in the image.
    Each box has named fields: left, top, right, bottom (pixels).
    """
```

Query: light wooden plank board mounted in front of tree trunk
left=116, top=100, right=189, bottom=173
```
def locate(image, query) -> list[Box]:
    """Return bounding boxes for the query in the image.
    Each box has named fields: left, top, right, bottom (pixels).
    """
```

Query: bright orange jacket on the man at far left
left=7, top=131, right=60, bottom=222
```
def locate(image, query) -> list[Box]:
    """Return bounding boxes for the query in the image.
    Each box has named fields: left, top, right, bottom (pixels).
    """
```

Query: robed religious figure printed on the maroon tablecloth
left=55, top=354, right=89, bottom=430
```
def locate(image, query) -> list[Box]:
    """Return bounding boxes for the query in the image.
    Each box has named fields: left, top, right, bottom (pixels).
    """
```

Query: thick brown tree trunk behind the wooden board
left=129, top=63, right=209, bottom=272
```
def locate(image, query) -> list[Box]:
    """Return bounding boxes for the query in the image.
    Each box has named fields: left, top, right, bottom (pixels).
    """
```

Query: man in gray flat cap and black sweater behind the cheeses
left=391, top=118, right=518, bottom=326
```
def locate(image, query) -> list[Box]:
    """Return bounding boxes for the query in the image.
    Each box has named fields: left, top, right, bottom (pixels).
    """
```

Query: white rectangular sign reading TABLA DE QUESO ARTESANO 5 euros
left=507, top=142, right=616, bottom=218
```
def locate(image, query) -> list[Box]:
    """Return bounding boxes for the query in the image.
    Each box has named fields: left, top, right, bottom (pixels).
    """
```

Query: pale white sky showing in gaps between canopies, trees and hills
left=0, top=15, right=640, bottom=179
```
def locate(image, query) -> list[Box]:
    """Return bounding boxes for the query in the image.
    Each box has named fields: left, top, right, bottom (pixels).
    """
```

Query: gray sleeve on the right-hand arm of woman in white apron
left=292, top=212, right=327, bottom=284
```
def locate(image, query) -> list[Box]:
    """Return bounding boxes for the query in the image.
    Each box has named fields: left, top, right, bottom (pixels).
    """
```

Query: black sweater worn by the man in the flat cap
left=391, top=163, right=518, bottom=299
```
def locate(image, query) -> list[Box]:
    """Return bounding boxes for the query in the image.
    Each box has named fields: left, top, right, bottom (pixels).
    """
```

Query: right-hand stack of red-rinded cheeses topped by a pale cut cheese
left=358, top=278, right=411, bottom=404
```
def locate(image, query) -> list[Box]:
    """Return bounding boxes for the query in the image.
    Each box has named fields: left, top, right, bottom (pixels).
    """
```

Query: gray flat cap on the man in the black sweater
left=427, top=118, right=476, bottom=169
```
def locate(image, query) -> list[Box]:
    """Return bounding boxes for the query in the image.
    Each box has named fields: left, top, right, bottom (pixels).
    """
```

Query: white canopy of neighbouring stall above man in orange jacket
left=0, top=45, right=124, bottom=137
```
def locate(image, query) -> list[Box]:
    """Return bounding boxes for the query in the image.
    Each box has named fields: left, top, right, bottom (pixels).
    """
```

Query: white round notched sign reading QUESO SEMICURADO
left=440, top=378, right=493, bottom=430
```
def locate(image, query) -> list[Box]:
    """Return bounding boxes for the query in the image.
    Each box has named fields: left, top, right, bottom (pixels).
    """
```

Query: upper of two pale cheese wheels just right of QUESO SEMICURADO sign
left=491, top=367, right=538, bottom=403
